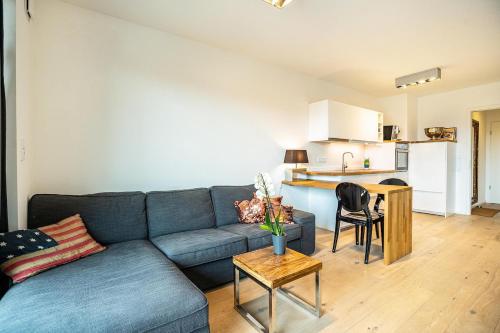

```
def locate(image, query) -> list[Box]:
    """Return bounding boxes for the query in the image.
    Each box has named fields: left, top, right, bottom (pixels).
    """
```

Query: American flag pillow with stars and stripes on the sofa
left=0, top=214, right=106, bottom=283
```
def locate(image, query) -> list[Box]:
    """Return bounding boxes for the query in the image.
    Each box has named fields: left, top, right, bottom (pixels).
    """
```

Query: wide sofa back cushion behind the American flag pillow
left=28, top=192, right=148, bottom=245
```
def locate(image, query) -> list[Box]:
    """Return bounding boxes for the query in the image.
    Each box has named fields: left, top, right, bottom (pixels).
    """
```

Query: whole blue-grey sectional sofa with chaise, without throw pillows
left=0, top=186, right=315, bottom=333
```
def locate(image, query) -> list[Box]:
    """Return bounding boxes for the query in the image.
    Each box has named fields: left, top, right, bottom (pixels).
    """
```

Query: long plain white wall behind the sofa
left=20, top=0, right=376, bottom=208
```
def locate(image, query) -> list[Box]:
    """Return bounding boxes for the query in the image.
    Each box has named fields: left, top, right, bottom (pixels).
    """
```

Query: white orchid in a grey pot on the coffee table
left=255, top=173, right=286, bottom=255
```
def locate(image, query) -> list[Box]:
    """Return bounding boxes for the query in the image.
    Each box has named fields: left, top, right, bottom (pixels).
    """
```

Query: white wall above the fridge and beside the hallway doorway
left=417, top=82, right=500, bottom=214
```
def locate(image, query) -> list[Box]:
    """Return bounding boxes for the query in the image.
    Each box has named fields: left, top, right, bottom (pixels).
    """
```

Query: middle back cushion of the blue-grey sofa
left=146, top=188, right=215, bottom=238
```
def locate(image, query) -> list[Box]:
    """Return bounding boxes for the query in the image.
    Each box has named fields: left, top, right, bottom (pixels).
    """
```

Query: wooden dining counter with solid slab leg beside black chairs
left=283, top=180, right=412, bottom=265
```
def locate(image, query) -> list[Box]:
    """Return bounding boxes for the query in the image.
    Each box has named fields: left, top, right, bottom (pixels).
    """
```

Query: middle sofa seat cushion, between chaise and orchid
left=151, top=228, right=247, bottom=268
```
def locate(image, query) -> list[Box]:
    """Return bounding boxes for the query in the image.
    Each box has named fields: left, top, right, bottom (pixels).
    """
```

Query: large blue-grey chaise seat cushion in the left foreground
left=0, top=240, right=208, bottom=332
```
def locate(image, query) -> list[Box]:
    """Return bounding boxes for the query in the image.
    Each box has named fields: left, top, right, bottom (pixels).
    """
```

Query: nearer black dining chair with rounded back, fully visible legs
left=332, top=183, right=384, bottom=264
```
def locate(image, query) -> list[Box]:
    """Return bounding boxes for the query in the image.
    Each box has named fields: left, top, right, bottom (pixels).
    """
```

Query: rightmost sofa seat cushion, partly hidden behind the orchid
left=219, top=223, right=302, bottom=251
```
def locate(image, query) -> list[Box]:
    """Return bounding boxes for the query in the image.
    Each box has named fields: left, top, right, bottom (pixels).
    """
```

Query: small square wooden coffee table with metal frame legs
left=233, top=246, right=322, bottom=333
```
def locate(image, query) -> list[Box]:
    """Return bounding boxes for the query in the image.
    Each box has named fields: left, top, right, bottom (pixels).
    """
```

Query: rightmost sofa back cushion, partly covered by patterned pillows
left=210, top=185, right=256, bottom=227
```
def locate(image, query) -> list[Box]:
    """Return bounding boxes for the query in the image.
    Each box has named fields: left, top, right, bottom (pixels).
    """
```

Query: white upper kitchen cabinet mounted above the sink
left=309, top=100, right=384, bottom=142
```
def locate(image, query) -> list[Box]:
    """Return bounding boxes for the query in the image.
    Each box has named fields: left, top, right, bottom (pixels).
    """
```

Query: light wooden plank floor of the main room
left=207, top=214, right=500, bottom=333
